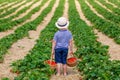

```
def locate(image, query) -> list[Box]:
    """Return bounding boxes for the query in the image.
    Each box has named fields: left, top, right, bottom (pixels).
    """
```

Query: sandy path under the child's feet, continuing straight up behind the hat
left=50, top=0, right=81, bottom=80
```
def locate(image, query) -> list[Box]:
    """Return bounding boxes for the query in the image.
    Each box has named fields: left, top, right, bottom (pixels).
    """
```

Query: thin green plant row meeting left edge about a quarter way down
left=0, top=0, right=38, bottom=23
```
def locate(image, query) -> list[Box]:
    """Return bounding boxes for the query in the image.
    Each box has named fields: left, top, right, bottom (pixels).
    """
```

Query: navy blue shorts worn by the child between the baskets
left=55, top=48, right=68, bottom=64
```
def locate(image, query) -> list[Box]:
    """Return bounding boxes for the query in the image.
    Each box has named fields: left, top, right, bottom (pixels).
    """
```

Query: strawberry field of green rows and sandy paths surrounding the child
left=0, top=0, right=120, bottom=80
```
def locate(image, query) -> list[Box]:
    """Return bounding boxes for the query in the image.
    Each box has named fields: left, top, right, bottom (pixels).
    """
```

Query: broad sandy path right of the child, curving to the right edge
left=75, top=0, right=120, bottom=60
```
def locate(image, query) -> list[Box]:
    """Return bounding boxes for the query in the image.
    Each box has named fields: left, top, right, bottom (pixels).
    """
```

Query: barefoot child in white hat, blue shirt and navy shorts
left=52, top=17, right=73, bottom=76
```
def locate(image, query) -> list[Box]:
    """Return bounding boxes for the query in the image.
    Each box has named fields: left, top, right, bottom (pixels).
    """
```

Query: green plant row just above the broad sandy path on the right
left=78, top=1, right=120, bottom=44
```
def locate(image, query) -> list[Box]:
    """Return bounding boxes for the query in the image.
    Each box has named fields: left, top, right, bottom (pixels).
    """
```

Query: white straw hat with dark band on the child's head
left=55, top=17, right=69, bottom=29
